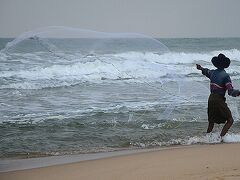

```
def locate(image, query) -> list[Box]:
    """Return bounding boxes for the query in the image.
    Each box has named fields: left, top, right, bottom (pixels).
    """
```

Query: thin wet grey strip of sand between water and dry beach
left=0, top=144, right=206, bottom=173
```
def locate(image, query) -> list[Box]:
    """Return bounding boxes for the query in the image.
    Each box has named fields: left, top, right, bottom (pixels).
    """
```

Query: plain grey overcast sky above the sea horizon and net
left=0, top=0, right=240, bottom=37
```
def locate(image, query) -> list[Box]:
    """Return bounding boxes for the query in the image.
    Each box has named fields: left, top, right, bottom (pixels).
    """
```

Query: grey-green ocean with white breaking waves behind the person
left=0, top=31, right=240, bottom=158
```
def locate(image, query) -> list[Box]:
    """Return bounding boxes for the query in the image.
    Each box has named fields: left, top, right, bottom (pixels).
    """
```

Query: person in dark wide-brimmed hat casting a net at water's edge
left=196, top=54, right=240, bottom=141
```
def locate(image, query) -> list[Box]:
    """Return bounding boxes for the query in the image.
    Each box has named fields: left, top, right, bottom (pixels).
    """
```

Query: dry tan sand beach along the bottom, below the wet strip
left=0, top=144, right=240, bottom=180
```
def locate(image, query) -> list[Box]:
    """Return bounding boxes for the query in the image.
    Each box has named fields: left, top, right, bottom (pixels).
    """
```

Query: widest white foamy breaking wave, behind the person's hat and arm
left=0, top=49, right=240, bottom=89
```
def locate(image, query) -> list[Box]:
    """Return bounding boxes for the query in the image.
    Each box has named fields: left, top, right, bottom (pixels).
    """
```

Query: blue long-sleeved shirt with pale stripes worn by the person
left=202, top=68, right=240, bottom=97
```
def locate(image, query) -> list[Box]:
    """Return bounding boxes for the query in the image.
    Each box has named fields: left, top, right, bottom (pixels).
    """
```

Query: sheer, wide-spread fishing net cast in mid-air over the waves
left=0, top=27, right=229, bottom=121
